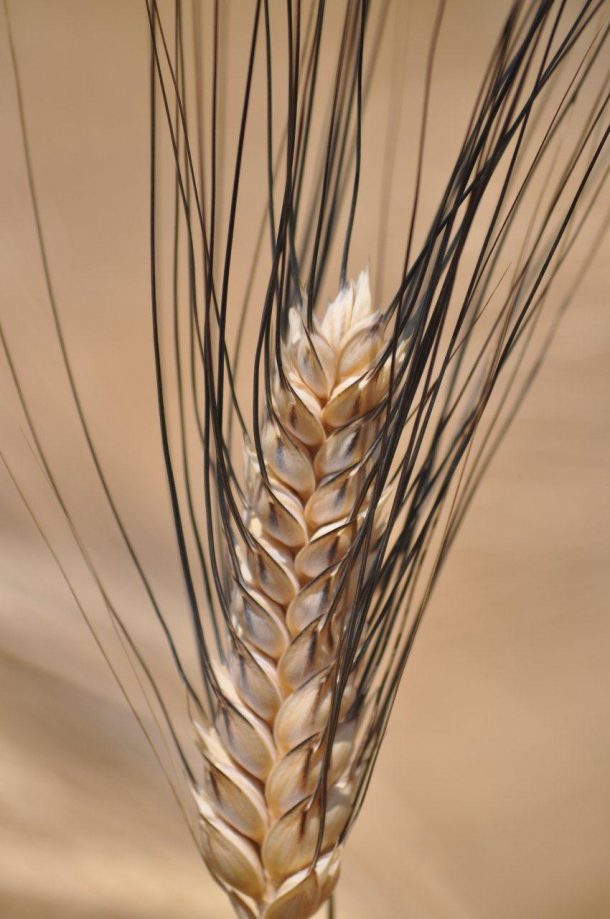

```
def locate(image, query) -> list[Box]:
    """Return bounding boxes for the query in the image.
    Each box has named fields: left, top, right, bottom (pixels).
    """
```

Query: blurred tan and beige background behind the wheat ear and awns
left=0, top=0, right=610, bottom=919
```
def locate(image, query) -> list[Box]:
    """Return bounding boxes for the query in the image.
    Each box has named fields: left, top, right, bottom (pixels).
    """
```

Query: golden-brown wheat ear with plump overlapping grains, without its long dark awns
left=195, top=271, right=389, bottom=919
